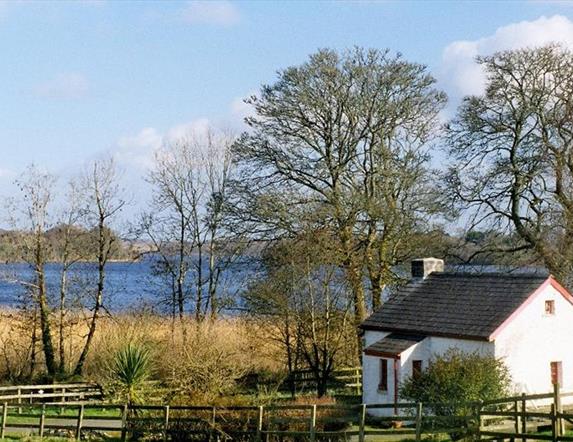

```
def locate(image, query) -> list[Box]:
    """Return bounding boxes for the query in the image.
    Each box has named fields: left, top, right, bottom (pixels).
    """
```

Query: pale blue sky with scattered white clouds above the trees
left=0, top=0, right=573, bottom=218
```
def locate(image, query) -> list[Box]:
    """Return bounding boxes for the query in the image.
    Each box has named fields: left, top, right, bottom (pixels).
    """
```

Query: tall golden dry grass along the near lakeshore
left=0, top=309, right=284, bottom=403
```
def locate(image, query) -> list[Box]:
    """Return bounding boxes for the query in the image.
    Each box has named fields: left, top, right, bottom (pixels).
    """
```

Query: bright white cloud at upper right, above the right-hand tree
left=440, top=15, right=573, bottom=97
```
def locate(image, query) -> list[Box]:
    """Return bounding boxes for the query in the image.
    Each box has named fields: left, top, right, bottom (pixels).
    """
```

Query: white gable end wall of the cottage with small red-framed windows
left=495, top=286, right=573, bottom=393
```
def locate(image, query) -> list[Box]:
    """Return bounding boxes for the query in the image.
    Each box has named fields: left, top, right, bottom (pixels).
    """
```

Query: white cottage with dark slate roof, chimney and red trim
left=361, top=258, right=573, bottom=412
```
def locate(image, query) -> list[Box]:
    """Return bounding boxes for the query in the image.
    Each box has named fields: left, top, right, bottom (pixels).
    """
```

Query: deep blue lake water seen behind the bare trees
left=0, top=260, right=253, bottom=312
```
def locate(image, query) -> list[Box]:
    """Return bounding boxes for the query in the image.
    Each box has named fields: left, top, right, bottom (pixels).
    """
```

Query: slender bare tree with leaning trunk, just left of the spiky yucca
left=74, top=158, right=125, bottom=375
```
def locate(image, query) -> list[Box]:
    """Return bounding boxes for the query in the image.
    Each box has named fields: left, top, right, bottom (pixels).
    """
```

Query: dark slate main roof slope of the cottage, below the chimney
left=361, top=272, right=547, bottom=340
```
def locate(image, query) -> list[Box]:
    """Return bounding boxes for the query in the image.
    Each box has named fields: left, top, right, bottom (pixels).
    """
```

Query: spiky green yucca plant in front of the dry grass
left=111, top=343, right=151, bottom=405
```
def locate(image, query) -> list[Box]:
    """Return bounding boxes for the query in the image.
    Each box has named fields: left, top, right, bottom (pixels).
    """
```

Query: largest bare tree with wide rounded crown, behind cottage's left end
left=234, top=48, right=446, bottom=334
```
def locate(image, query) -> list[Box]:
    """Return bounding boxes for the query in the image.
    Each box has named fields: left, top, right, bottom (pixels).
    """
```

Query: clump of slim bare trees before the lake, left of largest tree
left=142, top=129, right=237, bottom=321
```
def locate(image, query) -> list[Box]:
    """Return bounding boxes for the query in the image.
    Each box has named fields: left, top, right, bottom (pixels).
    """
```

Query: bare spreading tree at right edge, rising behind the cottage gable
left=447, top=45, right=573, bottom=283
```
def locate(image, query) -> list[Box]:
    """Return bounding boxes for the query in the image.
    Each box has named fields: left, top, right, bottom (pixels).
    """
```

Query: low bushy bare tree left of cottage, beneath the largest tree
left=245, top=232, right=356, bottom=396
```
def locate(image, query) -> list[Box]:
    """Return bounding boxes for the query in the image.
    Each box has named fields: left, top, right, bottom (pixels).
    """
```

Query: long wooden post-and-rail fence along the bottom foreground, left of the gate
left=0, top=403, right=475, bottom=442
